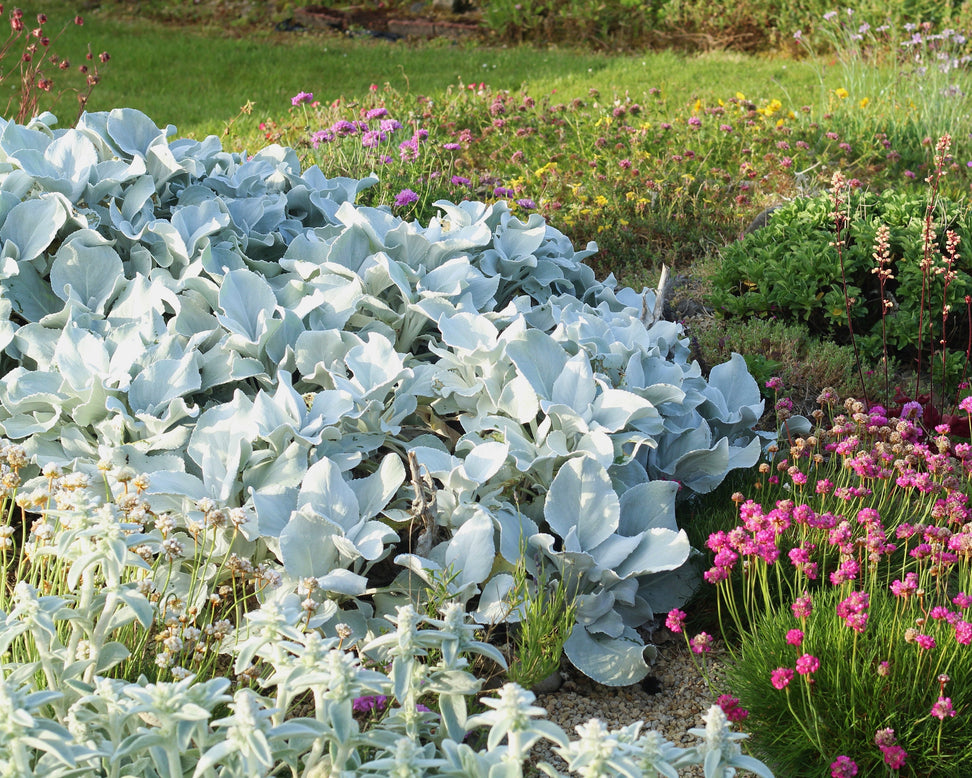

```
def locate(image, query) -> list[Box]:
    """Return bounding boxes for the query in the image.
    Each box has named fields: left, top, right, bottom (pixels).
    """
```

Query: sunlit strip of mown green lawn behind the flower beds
left=25, top=0, right=818, bottom=136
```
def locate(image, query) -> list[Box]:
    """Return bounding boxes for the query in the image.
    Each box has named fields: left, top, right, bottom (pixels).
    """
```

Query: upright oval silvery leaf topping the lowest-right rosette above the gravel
left=543, top=457, right=621, bottom=551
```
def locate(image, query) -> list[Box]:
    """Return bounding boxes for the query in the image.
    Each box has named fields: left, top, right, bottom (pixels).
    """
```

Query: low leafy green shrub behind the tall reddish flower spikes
left=709, top=178, right=972, bottom=400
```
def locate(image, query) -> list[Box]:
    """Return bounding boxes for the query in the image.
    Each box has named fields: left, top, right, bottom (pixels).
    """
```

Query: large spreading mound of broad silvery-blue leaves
left=0, top=104, right=763, bottom=684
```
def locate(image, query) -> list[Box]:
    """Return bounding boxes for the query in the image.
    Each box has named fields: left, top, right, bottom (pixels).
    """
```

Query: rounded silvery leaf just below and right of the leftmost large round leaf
left=51, top=230, right=125, bottom=313
